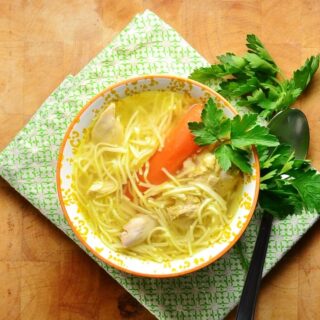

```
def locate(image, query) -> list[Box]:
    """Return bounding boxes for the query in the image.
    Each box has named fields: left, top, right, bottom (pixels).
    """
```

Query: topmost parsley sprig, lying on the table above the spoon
left=190, top=34, right=320, bottom=120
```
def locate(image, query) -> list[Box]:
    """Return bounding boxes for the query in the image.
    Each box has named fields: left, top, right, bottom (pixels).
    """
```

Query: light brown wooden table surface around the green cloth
left=0, top=0, right=320, bottom=320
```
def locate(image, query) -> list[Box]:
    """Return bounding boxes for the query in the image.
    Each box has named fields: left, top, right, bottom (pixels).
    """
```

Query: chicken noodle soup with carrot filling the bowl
left=72, top=91, right=243, bottom=261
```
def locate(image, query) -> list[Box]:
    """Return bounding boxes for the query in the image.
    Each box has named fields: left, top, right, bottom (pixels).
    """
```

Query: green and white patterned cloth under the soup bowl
left=0, top=11, right=317, bottom=320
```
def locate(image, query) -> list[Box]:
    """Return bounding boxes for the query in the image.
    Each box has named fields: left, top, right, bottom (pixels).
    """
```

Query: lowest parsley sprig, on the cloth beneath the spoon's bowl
left=258, top=145, right=320, bottom=218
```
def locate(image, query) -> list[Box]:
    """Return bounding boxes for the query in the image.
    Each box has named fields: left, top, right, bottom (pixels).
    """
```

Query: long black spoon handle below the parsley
left=236, top=213, right=273, bottom=320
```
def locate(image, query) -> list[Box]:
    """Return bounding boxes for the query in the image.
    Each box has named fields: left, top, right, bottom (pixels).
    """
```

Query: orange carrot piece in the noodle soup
left=139, top=104, right=203, bottom=191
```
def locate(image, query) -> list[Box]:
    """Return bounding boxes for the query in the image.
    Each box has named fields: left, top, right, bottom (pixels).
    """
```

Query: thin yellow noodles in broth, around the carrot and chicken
left=72, top=91, right=242, bottom=261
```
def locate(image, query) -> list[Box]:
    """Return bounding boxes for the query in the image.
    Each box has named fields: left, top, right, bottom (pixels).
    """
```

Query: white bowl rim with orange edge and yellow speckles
left=56, top=75, right=259, bottom=278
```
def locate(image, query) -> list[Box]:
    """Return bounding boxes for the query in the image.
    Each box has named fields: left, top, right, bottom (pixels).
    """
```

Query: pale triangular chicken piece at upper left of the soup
left=91, top=103, right=123, bottom=144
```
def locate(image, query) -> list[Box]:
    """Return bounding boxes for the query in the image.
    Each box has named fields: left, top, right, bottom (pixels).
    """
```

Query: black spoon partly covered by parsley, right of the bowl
left=236, top=109, right=310, bottom=320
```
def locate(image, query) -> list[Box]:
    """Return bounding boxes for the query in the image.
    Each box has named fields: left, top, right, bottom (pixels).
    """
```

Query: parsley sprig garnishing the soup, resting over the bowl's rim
left=189, top=98, right=279, bottom=173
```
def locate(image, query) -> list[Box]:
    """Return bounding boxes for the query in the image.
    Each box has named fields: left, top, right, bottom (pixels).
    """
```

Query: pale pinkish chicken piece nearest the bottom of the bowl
left=120, top=215, right=157, bottom=248
